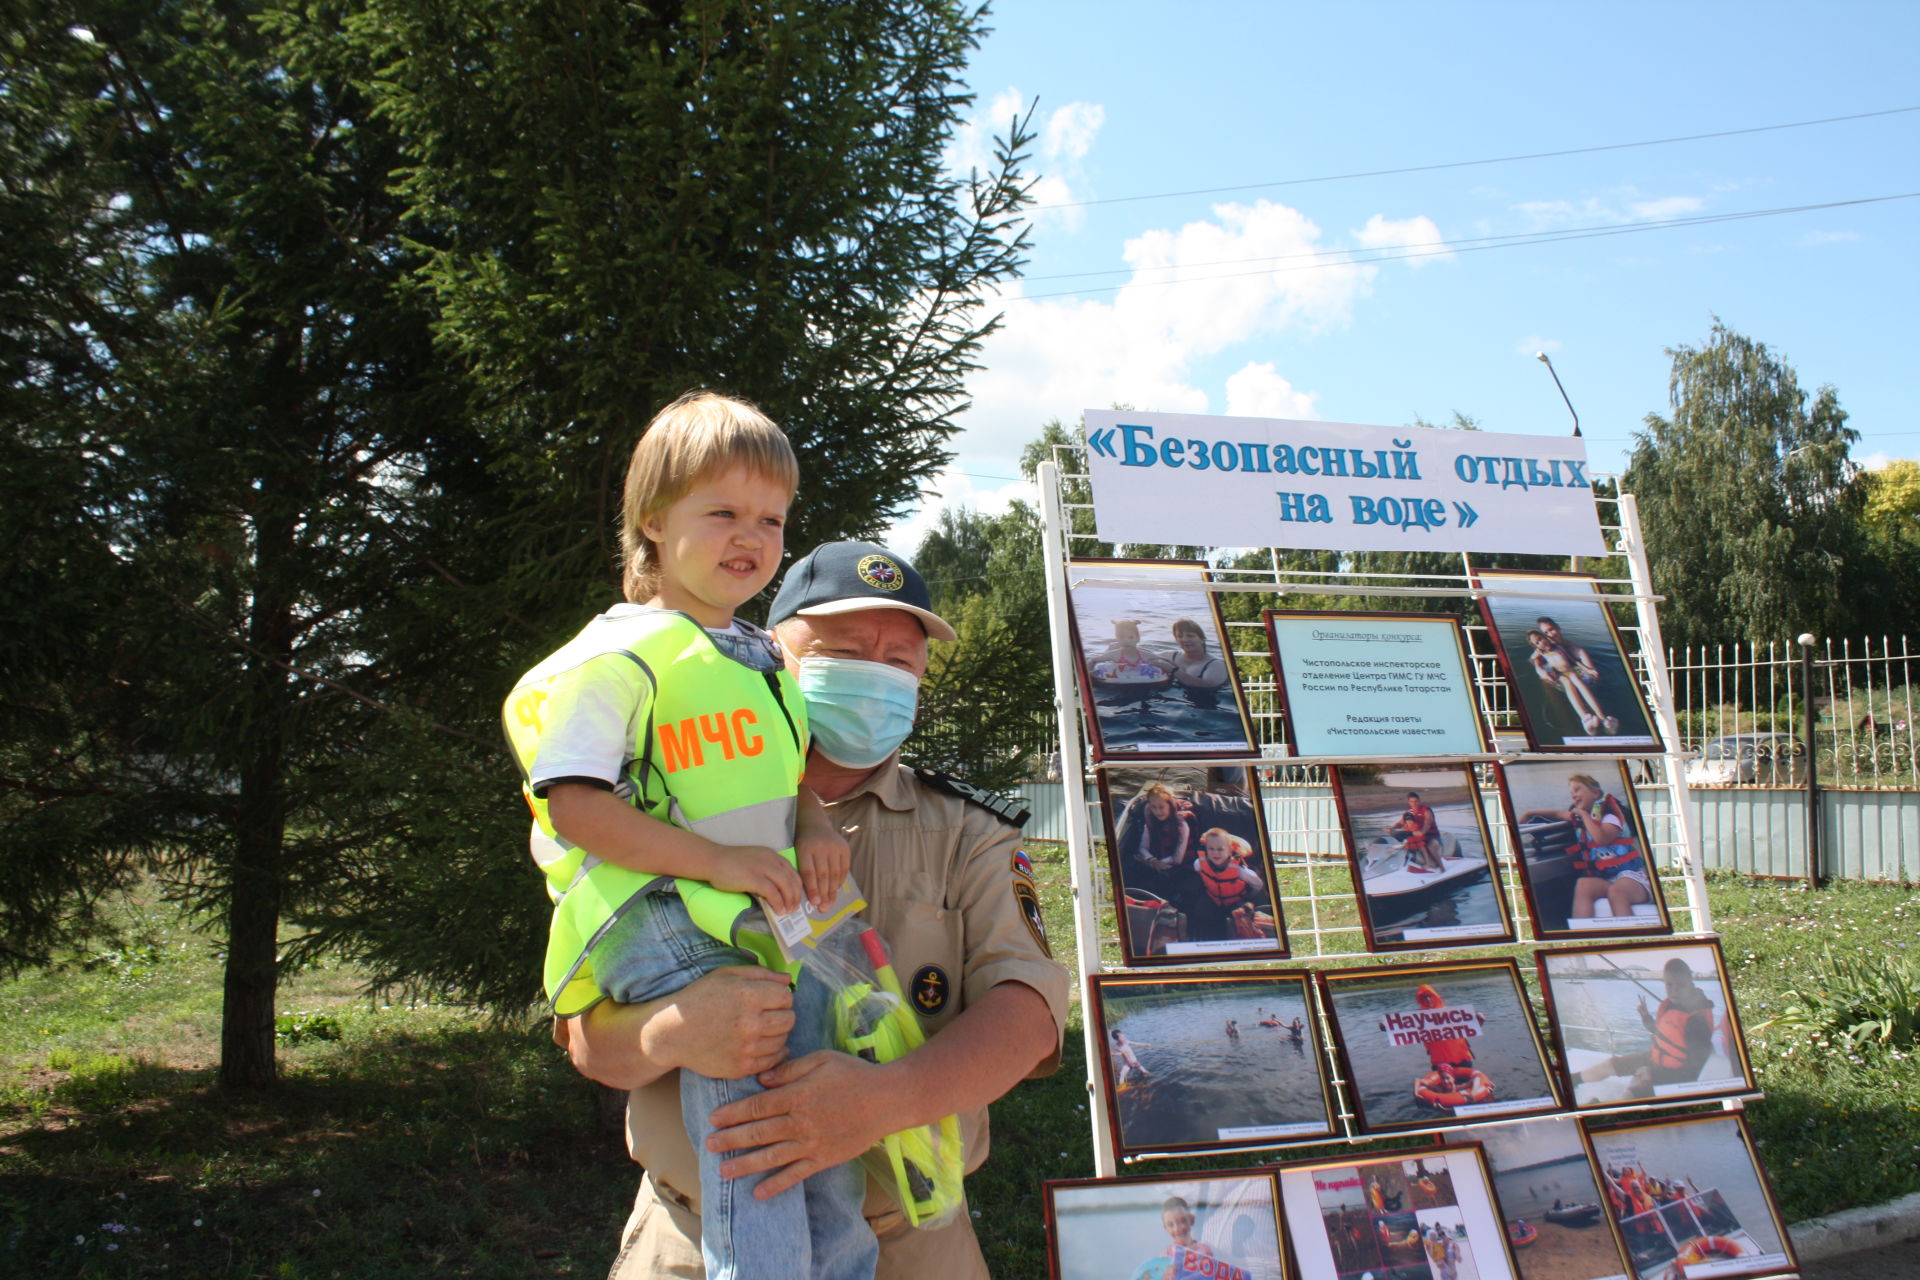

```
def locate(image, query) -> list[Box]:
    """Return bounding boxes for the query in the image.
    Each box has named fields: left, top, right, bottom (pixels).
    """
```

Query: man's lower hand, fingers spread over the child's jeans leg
left=707, top=1052, right=906, bottom=1199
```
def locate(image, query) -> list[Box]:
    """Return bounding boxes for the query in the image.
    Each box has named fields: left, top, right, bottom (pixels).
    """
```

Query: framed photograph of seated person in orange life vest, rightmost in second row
left=1500, top=760, right=1672, bottom=938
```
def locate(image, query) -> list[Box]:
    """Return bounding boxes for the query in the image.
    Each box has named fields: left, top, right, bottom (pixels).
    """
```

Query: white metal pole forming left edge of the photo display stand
left=1037, top=462, right=1116, bottom=1178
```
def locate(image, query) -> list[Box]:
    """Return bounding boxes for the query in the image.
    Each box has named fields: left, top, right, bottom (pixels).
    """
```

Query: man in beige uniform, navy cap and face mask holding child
left=555, top=543, right=1068, bottom=1280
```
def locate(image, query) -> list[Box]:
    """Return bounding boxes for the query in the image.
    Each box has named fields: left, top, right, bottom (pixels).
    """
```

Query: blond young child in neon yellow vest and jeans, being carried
left=505, top=391, right=877, bottom=1280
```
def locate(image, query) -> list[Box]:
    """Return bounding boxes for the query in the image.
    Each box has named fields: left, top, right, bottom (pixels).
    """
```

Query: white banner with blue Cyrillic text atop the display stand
left=1087, top=409, right=1607, bottom=555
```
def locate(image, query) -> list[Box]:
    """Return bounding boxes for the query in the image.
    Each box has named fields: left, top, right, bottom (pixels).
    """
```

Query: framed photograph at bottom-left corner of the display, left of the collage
left=1041, top=1169, right=1292, bottom=1280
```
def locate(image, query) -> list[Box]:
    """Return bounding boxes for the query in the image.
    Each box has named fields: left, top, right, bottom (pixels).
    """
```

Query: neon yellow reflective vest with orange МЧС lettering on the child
left=503, top=610, right=806, bottom=1017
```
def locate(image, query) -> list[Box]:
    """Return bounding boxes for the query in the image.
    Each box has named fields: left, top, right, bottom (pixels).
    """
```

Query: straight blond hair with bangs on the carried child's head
left=620, top=391, right=801, bottom=604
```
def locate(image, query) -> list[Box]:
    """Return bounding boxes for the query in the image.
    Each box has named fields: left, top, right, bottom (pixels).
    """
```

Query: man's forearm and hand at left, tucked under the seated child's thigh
left=553, top=965, right=793, bottom=1088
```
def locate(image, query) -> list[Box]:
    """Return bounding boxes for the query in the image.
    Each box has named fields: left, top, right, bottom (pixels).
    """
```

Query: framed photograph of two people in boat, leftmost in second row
left=1100, top=764, right=1286, bottom=965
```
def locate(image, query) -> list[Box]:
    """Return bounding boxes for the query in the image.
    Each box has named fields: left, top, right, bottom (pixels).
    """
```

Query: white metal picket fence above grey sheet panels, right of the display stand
left=1667, top=635, right=1920, bottom=787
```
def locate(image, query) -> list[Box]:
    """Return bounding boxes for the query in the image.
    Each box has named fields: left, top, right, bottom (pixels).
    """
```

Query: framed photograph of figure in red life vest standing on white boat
left=1329, top=764, right=1513, bottom=952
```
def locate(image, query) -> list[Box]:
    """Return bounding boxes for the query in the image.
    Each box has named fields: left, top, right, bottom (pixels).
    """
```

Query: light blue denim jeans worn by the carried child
left=593, top=890, right=879, bottom=1280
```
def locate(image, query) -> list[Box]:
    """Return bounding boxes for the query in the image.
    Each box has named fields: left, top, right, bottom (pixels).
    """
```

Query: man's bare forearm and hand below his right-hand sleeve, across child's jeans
left=707, top=983, right=1060, bottom=1199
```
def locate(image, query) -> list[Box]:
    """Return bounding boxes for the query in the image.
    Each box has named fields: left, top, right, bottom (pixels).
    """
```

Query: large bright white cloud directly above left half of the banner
left=956, top=200, right=1379, bottom=457
